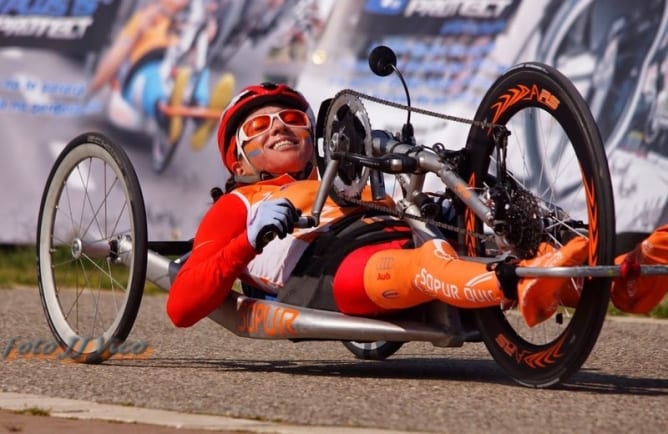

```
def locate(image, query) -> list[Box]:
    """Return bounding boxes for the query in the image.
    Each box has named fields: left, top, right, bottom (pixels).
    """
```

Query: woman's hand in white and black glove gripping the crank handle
left=246, top=198, right=301, bottom=253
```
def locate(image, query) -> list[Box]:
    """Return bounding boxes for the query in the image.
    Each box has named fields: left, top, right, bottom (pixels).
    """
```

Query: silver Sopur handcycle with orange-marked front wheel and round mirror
left=36, top=47, right=667, bottom=388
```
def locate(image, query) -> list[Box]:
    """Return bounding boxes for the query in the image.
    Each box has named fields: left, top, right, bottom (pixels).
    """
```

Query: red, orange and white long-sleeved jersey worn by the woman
left=167, top=175, right=393, bottom=327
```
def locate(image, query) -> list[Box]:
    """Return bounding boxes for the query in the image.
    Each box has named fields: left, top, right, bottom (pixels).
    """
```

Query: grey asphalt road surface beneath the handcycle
left=0, top=288, right=668, bottom=433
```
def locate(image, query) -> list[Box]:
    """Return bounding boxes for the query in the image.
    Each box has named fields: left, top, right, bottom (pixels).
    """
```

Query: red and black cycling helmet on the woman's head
left=218, top=83, right=315, bottom=173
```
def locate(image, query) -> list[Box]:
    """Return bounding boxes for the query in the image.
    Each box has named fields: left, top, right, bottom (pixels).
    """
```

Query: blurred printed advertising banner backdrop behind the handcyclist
left=0, top=0, right=668, bottom=244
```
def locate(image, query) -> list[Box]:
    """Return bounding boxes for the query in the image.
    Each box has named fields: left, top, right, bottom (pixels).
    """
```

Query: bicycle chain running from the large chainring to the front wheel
left=333, top=89, right=500, bottom=241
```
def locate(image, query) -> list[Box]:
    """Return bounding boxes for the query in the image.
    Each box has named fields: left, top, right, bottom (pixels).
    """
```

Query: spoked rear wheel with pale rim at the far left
left=36, top=133, right=147, bottom=363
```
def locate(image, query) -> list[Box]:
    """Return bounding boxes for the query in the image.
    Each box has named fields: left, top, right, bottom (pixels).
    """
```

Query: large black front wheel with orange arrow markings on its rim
left=461, top=63, right=615, bottom=387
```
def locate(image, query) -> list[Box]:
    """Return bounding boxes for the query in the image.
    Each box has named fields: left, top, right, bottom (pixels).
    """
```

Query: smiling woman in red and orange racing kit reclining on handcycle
left=167, top=83, right=668, bottom=327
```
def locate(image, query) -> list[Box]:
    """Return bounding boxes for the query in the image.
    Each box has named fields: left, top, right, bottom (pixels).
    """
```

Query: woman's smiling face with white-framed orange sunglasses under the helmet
left=232, top=105, right=314, bottom=176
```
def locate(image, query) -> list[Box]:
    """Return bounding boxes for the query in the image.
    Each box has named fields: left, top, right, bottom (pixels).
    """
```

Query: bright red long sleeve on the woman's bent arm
left=167, top=194, right=256, bottom=327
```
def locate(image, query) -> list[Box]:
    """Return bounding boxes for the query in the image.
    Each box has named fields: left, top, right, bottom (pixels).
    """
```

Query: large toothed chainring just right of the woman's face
left=324, top=91, right=373, bottom=199
